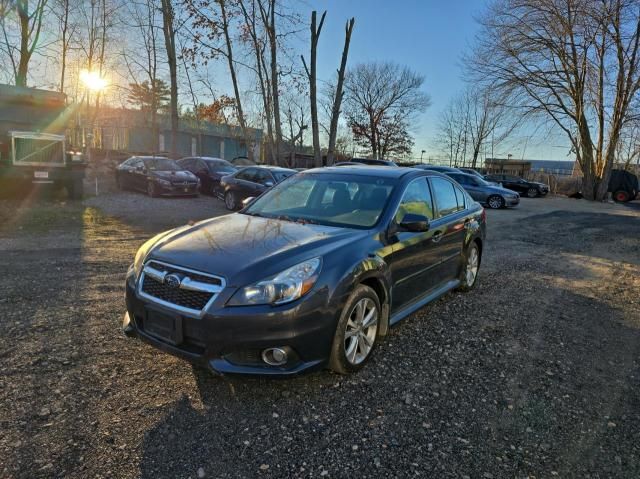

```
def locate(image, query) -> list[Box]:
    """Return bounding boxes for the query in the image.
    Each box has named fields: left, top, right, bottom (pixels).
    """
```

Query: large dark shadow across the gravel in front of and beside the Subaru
left=139, top=265, right=640, bottom=478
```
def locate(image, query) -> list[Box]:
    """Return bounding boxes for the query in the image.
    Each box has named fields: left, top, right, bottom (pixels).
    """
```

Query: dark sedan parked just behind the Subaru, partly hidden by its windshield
left=220, top=166, right=297, bottom=211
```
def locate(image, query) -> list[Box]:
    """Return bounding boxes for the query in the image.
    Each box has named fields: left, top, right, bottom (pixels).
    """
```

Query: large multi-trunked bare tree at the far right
left=467, top=0, right=640, bottom=200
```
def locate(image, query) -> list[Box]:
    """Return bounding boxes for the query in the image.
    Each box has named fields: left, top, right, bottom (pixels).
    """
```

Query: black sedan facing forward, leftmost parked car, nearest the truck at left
left=116, top=156, right=199, bottom=196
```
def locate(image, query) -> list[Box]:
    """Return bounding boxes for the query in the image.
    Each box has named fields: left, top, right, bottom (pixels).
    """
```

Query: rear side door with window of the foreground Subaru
left=429, top=177, right=468, bottom=285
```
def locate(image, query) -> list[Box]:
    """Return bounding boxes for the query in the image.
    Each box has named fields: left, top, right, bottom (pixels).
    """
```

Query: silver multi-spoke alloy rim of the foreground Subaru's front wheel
left=344, top=298, right=378, bottom=365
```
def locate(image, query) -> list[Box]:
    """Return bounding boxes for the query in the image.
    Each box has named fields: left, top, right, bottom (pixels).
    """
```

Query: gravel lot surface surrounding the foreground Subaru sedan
left=0, top=193, right=640, bottom=479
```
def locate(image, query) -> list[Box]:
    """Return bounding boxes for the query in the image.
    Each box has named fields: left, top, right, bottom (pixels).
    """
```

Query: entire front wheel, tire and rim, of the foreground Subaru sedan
left=329, top=284, right=382, bottom=374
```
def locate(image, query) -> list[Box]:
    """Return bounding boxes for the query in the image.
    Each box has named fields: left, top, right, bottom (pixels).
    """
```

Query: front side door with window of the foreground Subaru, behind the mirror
left=387, top=177, right=439, bottom=311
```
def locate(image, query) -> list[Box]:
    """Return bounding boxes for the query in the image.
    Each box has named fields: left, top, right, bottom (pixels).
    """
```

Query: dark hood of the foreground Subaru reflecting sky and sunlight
left=147, top=213, right=368, bottom=286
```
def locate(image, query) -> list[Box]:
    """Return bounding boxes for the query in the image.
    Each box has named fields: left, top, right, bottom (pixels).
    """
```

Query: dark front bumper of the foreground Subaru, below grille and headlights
left=122, top=279, right=338, bottom=376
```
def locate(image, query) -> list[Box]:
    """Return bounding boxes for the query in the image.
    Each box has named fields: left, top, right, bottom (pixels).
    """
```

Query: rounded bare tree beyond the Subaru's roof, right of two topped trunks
left=345, top=62, right=429, bottom=158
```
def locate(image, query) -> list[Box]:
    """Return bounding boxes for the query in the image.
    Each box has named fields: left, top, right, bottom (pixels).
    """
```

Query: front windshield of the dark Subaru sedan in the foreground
left=243, top=173, right=396, bottom=229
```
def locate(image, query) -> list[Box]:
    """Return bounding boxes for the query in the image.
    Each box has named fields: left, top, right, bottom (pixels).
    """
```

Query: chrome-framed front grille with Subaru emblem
left=138, top=260, right=225, bottom=317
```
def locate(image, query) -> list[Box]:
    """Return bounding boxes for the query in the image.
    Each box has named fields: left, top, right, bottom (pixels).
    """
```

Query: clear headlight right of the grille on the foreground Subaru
left=229, top=258, right=322, bottom=306
